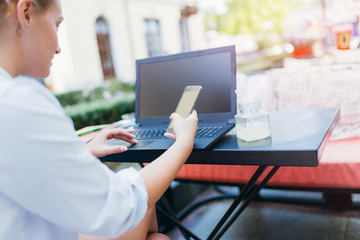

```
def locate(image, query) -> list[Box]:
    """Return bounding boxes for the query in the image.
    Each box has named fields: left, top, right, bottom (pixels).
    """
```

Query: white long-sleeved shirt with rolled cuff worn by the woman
left=0, top=68, right=148, bottom=240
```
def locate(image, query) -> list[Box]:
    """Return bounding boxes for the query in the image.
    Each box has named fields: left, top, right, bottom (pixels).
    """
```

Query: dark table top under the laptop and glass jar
left=101, top=108, right=340, bottom=166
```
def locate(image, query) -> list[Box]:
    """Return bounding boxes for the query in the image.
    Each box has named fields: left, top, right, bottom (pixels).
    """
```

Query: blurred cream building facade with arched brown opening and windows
left=45, top=0, right=205, bottom=93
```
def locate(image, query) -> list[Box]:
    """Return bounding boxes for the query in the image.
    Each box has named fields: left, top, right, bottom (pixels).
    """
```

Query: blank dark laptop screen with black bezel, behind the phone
left=136, top=46, right=236, bottom=124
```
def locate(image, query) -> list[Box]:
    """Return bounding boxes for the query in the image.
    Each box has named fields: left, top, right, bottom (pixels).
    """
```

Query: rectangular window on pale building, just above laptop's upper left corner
left=144, top=19, right=163, bottom=57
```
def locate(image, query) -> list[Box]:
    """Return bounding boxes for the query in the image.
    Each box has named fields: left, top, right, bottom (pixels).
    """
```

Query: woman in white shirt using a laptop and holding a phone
left=0, top=0, right=197, bottom=240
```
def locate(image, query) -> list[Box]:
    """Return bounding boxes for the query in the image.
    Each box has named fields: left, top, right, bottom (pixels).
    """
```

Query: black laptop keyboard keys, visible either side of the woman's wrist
left=133, top=127, right=223, bottom=140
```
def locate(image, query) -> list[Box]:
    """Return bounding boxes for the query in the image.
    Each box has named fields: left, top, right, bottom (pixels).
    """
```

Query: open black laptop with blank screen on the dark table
left=108, top=46, right=236, bottom=150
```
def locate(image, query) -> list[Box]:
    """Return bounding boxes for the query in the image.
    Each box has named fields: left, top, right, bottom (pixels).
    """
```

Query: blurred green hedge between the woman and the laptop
left=55, top=80, right=135, bottom=129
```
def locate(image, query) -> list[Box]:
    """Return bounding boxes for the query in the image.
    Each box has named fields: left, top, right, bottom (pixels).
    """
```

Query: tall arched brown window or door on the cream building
left=95, top=17, right=115, bottom=79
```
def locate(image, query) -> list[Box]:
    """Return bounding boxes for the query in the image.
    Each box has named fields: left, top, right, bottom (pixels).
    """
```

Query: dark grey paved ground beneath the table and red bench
left=168, top=187, right=360, bottom=240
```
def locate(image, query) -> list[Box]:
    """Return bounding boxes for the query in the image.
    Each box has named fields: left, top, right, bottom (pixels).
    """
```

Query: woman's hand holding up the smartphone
left=165, top=110, right=198, bottom=141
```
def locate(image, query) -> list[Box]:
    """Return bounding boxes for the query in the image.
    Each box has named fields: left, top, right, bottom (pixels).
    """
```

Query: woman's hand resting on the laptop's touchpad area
left=88, top=128, right=137, bottom=157
